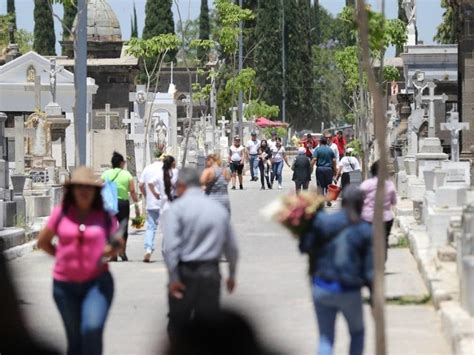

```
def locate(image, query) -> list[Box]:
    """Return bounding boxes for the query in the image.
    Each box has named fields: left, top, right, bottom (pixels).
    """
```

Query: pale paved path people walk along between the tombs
left=10, top=172, right=450, bottom=355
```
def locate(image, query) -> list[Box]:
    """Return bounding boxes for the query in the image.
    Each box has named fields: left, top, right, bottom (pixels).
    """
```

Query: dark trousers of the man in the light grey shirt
left=168, top=261, right=221, bottom=339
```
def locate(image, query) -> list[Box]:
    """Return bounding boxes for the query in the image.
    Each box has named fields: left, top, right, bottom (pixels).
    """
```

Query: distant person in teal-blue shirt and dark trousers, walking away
left=311, top=137, right=337, bottom=207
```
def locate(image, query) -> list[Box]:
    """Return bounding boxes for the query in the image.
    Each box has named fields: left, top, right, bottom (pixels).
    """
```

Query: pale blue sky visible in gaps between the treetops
left=0, top=0, right=443, bottom=56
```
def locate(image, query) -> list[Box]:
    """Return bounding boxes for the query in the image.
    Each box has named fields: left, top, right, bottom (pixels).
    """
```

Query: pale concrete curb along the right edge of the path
left=397, top=206, right=474, bottom=355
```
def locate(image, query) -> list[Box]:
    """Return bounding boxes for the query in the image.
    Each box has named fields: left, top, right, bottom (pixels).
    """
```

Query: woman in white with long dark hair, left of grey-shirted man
left=143, top=155, right=178, bottom=263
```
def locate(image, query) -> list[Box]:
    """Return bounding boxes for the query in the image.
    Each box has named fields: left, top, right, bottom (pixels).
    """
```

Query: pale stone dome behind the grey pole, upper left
left=73, top=0, right=122, bottom=42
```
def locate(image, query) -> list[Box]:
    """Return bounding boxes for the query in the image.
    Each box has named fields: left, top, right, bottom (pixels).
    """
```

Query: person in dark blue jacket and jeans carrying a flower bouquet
left=300, top=186, right=374, bottom=355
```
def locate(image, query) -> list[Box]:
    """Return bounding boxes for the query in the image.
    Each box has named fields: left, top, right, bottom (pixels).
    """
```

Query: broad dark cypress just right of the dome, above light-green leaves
left=142, top=0, right=176, bottom=60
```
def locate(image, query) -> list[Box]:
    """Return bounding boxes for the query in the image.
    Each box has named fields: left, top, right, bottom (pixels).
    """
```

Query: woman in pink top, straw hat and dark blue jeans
left=38, top=167, right=123, bottom=355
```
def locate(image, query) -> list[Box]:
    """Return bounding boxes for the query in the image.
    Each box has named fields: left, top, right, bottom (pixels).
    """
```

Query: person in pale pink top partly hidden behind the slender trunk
left=360, top=161, right=397, bottom=260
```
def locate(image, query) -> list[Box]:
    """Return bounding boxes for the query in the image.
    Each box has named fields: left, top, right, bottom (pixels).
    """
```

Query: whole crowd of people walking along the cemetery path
left=21, top=129, right=397, bottom=355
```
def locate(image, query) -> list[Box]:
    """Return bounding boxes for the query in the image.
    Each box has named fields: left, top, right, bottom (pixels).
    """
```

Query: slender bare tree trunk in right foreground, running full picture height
left=357, top=0, right=387, bottom=355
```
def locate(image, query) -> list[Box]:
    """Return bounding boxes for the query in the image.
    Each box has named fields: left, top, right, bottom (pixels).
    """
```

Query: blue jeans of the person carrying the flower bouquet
left=313, top=285, right=364, bottom=355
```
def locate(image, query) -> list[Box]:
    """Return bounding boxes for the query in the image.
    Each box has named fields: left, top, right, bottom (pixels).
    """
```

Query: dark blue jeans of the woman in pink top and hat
left=53, top=272, right=114, bottom=355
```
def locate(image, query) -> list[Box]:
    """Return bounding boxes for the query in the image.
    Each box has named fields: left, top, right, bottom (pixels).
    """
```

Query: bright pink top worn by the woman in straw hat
left=47, top=206, right=118, bottom=282
